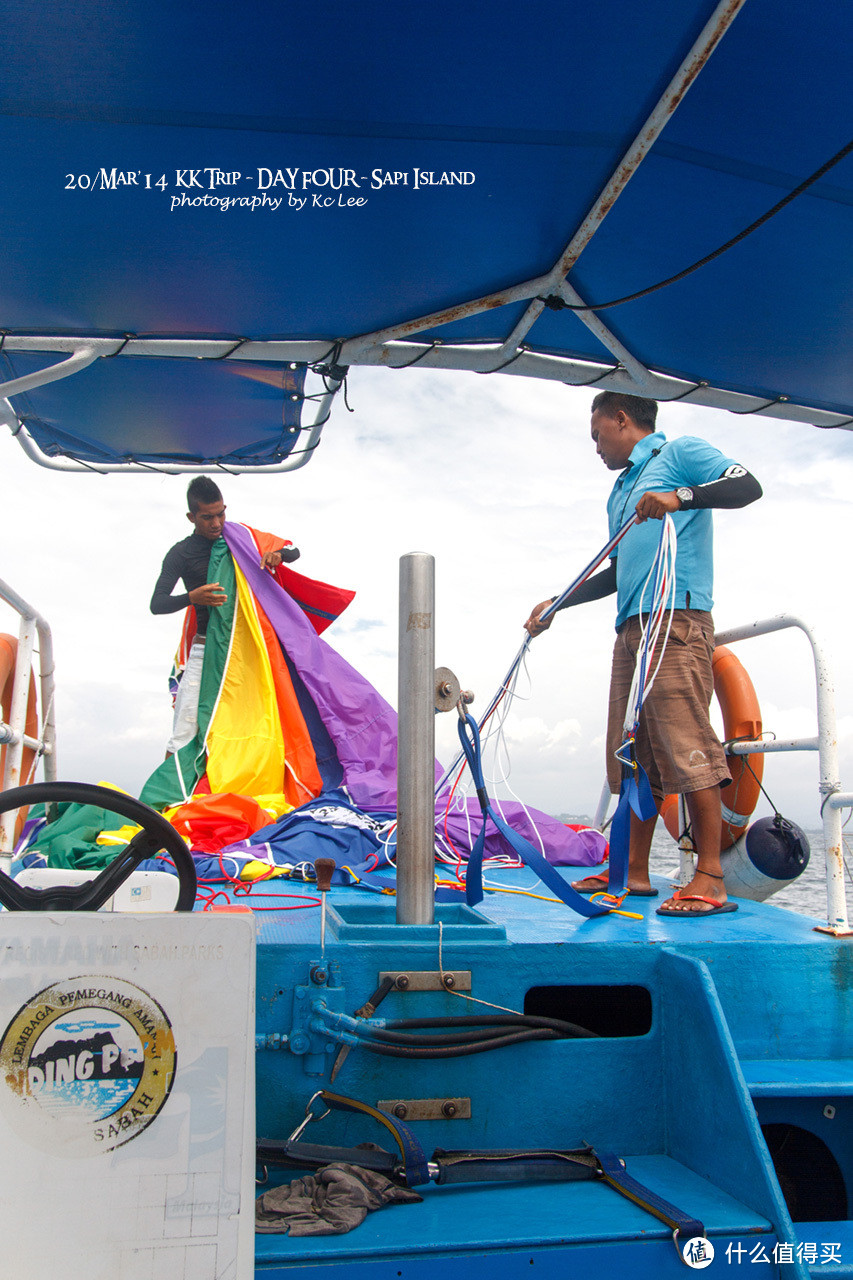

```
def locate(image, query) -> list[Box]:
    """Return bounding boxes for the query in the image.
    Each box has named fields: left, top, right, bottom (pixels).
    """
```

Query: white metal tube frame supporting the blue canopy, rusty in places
left=0, top=0, right=853, bottom=474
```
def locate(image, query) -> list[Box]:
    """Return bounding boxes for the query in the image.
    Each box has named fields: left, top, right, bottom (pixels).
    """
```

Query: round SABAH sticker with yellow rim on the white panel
left=0, top=974, right=177, bottom=1156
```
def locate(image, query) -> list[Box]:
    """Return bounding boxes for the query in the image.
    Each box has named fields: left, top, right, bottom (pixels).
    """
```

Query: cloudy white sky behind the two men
left=0, top=369, right=853, bottom=828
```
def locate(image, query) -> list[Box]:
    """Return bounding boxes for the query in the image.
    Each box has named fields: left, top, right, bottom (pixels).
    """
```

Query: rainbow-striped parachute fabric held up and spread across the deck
left=134, top=524, right=605, bottom=865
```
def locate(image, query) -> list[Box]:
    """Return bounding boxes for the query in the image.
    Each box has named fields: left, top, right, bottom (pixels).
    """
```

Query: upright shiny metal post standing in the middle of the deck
left=397, top=552, right=435, bottom=924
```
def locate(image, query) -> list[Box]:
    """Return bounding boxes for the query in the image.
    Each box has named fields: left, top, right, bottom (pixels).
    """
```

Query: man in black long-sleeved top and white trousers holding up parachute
left=151, top=476, right=300, bottom=755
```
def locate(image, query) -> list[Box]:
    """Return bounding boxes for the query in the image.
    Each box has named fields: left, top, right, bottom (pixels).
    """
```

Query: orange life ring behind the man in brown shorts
left=661, top=645, right=765, bottom=851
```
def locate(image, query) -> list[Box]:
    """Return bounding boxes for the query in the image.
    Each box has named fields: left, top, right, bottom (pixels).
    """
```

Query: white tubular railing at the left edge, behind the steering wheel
left=0, top=581, right=56, bottom=870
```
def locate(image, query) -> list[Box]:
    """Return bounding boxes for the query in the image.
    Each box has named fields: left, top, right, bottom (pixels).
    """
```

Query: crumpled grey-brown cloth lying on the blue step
left=255, top=1164, right=423, bottom=1235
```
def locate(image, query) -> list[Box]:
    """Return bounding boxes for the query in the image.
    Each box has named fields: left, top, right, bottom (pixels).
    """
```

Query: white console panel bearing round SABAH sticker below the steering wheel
left=0, top=911, right=255, bottom=1280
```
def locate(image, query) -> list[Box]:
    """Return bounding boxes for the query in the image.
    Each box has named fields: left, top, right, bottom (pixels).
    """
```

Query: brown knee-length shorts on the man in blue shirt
left=607, top=609, right=731, bottom=800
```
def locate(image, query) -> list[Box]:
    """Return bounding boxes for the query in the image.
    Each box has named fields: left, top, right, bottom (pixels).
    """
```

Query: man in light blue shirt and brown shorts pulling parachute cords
left=525, top=392, right=761, bottom=918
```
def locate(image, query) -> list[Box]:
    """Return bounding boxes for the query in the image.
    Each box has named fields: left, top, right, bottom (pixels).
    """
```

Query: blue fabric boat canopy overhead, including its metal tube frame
left=0, top=0, right=853, bottom=470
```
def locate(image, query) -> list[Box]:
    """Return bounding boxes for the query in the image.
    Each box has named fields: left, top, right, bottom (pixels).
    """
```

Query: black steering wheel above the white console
left=0, top=782, right=199, bottom=911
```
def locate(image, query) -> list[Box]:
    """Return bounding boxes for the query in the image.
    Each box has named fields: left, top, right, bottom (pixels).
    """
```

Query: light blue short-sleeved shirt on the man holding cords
left=607, top=431, right=735, bottom=627
